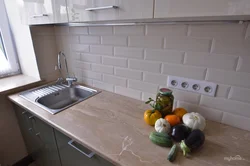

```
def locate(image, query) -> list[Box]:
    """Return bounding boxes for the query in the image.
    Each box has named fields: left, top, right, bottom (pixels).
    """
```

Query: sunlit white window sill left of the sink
left=0, top=74, right=41, bottom=94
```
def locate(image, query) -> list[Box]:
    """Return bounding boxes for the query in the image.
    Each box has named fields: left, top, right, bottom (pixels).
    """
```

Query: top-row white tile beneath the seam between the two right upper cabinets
left=146, top=25, right=188, bottom=36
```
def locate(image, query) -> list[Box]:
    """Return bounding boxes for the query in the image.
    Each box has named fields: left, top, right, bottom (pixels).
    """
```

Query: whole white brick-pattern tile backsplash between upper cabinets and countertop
left=46, top=23, right=250, bottom=131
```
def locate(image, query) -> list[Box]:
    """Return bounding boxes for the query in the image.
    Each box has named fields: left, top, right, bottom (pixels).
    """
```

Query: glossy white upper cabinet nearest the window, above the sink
left=17, top=0, right=68, bottom=25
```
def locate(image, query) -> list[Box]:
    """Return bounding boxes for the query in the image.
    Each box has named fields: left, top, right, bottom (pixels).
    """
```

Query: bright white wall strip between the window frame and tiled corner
left=5, top=0, right=40, bottom=79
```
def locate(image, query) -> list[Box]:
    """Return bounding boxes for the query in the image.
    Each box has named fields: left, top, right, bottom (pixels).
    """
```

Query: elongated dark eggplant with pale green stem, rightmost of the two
left=180, top=129, right=205, bottom=156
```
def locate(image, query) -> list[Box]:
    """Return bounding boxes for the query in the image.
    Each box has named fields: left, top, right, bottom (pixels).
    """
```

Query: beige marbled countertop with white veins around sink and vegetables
left=9, top=85, right=250, bottom=166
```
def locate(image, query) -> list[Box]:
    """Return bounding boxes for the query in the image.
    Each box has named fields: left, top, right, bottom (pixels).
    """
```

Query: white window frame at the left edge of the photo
left=0, top=0, right=21, bottom=79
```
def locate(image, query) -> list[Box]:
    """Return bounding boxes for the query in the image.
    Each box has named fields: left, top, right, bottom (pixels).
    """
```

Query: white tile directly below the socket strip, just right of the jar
left=173, top=89, right=200, bottom=104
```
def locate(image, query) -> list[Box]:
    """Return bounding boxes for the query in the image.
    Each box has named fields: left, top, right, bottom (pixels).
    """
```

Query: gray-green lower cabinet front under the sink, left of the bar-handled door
left=14, top=105, right=61, bottom=166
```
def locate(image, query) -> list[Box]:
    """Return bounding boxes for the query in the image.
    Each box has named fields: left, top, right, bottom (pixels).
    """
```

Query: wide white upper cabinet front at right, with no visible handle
left=154, top=0, right=250, bottom=18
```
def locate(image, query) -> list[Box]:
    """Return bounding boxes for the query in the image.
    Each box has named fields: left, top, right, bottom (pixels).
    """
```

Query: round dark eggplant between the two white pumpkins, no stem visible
left=171, top=124, right=191, bottom=142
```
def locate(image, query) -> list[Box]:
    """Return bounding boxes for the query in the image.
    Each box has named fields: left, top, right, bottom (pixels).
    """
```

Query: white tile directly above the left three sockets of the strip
left=163, top=63, right=206, bottom=80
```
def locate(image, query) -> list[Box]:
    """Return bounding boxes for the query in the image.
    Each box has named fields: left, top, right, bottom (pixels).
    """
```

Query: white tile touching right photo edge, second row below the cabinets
left=212, top=39, right=250, bottom=56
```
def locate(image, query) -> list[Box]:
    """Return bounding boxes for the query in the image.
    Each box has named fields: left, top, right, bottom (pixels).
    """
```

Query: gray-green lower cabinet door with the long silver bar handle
left=55, top=130, right=113, bottom=166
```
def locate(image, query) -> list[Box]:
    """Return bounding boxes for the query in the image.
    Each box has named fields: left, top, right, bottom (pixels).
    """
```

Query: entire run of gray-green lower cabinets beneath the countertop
left=14, top=105, right=113, bottom=166
